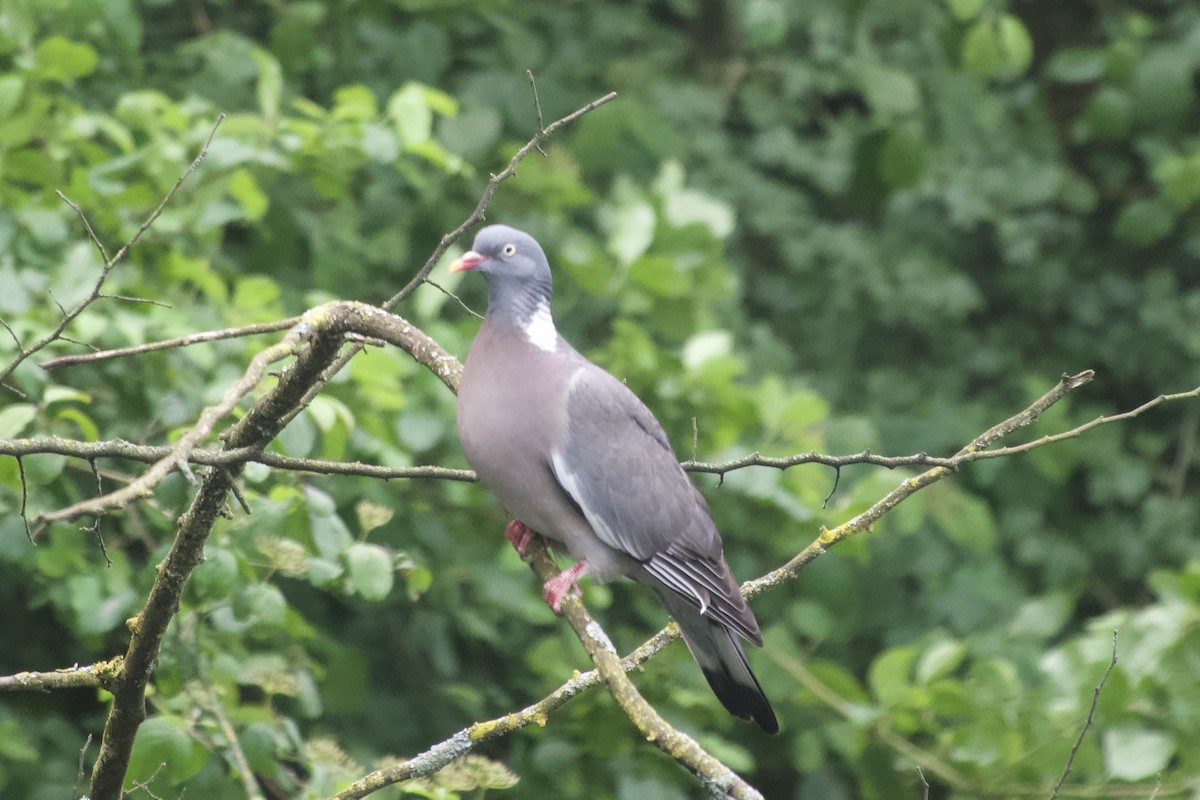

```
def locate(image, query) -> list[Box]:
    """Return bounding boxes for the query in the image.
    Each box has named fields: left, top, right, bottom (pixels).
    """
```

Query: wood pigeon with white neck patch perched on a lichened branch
left=450, top=225, right=779, bottom=733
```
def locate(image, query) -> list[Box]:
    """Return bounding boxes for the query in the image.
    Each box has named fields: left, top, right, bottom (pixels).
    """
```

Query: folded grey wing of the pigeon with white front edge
left=551, top=363, right=762, bottom=643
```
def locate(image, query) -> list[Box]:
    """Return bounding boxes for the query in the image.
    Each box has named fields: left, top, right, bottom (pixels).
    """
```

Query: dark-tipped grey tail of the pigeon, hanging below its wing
left=654, top=582, right=779, bottom=733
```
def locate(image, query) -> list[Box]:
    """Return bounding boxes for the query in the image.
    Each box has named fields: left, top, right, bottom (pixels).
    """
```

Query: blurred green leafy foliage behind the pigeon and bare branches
left=0, top=0, right=1200, bottom=800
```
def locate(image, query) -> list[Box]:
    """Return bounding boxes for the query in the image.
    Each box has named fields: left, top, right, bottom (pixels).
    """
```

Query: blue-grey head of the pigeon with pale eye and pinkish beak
left=450, top=225, right=553, bottom=326
